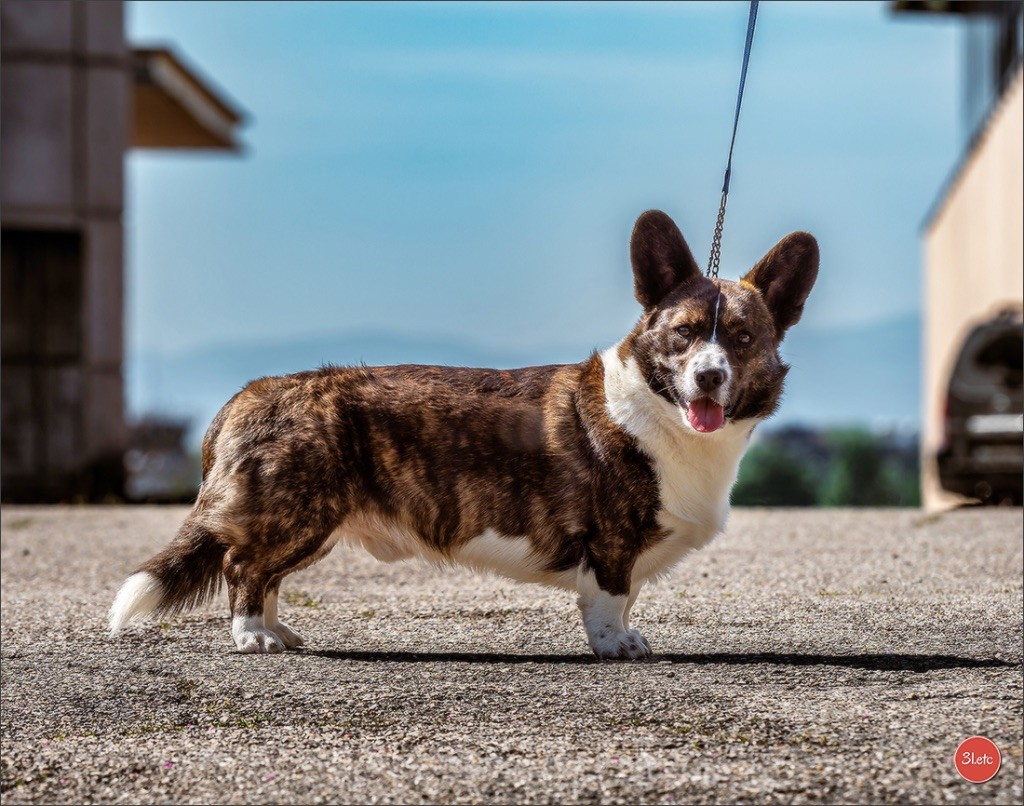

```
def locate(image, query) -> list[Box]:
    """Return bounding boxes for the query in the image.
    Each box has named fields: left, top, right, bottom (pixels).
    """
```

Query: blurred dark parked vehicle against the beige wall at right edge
left=937, top=311, right=1024, bottom=505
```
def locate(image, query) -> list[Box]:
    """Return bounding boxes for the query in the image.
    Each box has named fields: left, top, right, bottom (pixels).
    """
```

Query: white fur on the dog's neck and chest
left=601, top=347, right=755, bottom=580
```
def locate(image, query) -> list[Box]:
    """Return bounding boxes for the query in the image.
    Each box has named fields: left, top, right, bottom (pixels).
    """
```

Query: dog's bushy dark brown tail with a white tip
left=110, top=517, right=226, bottom=635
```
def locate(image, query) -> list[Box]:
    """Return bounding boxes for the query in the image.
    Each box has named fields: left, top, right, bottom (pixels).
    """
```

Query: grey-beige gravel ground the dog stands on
left=2, top=507, right=1022, bottom=804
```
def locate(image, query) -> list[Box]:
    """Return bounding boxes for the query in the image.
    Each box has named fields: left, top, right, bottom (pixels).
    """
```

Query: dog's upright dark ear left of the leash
left=630, top=210, right=700, bottom=308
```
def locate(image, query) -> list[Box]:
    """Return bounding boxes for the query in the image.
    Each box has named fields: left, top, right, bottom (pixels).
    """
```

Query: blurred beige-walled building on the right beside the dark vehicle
left=894, top=0, right=1024, bottom=508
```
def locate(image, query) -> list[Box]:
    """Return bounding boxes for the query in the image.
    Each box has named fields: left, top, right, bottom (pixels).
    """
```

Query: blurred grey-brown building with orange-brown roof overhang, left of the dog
left=0, top=0, right=242, bottom=501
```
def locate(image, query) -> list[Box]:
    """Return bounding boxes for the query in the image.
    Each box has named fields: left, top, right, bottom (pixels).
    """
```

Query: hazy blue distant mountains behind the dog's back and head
left=127, top=316, right=921, bottom=444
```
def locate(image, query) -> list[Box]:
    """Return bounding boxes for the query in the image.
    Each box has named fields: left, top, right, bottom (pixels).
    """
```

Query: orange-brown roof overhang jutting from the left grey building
left=131, top=47, right=245, bottom=152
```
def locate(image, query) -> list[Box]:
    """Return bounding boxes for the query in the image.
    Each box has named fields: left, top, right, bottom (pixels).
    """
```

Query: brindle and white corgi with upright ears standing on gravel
left=110, top=211, right=818, bottom=660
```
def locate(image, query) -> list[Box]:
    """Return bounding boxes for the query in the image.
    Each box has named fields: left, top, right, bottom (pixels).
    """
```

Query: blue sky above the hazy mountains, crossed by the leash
left=126, top=2, right=962, bottom=378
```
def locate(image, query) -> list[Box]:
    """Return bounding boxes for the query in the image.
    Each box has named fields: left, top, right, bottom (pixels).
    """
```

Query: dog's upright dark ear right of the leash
left=743, top=232, right=818, bottom=340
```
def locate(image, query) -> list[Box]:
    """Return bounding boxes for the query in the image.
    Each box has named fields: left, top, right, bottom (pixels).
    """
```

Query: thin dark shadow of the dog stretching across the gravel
left=301, top=649, right=1021, bottom=672
